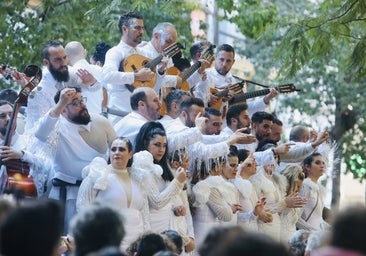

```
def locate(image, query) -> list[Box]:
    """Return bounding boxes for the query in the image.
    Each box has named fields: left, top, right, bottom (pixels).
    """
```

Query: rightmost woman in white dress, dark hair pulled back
left=297, top=152, right=330, bottom=230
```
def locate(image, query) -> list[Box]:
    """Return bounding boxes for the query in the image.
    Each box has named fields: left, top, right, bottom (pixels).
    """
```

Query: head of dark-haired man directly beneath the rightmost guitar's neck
left=226, top=103, right=251, bottom=132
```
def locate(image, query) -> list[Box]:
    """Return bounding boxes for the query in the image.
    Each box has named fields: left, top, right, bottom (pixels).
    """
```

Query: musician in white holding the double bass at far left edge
left=0, top=100, right=48, bottom=197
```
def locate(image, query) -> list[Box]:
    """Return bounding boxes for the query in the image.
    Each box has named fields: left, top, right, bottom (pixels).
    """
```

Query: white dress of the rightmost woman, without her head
left=297, top=178, right=329, bottom=230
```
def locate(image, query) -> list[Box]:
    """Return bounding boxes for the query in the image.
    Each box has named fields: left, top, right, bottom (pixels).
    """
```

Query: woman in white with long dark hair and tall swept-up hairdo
left=134, top=121, right=186, bottom=233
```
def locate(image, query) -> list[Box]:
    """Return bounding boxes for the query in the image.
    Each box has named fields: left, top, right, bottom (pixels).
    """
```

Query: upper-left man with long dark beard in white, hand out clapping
left=25, top=40, right=97, bottom=131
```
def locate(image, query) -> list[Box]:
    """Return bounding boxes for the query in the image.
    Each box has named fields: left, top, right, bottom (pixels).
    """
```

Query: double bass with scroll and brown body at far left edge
left=1, top=65, right=42, bottom=197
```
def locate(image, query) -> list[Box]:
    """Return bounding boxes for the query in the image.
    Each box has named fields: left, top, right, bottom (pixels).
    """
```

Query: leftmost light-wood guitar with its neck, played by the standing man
left=120, top=42, right=183, bottom=88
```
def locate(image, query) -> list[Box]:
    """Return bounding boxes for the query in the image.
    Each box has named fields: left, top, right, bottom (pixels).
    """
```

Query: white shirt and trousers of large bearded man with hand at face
left=35, top=113, right=116, bottom=230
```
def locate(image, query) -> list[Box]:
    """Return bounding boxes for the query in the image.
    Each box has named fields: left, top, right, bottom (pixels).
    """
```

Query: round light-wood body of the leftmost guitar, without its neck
left=123, top=54, right=156, bottom=88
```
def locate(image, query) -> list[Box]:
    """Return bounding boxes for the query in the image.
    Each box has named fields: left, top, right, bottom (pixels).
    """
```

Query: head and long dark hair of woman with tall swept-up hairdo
left=135, top=121, right=174, bottom=181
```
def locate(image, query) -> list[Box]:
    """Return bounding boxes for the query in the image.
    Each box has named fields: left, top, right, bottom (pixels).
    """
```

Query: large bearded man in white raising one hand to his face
left=35, top=88, right=117, bottom=233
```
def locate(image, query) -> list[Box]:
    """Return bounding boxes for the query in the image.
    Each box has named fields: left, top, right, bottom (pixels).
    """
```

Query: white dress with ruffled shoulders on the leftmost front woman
left=77, top=153, right=150, bottom=250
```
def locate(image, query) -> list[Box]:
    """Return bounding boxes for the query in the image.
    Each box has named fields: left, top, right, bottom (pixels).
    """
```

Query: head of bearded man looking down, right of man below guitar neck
left=252, top=111, right=273, bottom=141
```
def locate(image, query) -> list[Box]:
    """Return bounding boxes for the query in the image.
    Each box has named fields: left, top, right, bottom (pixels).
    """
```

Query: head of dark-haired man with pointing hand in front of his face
left=179, top=97, right=205, bottom=127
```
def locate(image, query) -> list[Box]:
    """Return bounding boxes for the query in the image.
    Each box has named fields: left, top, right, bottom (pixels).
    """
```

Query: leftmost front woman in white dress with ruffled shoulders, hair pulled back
left=77, top=137, right=150, bottom=249
